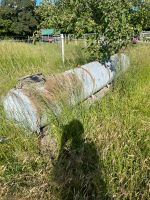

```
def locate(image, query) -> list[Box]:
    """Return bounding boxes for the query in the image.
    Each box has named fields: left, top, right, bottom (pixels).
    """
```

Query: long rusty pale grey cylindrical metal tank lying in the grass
left=3, top=54, right=129, bottom=132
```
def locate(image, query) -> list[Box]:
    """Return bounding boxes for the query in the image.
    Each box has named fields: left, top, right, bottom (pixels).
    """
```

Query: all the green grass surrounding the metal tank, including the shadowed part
left=0, top=41, right=150, bottom=200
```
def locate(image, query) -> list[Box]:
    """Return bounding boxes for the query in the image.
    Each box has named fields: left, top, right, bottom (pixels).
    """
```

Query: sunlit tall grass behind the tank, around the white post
left=0, top=41, right=85, bottom=95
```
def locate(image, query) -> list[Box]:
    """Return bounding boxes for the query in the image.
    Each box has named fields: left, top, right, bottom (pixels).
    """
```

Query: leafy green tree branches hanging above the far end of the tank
left=37, top=0, right=149, bottom=59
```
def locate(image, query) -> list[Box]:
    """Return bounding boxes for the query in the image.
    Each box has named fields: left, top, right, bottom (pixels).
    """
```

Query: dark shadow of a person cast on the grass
left=54, top=120, right=110, bottom=200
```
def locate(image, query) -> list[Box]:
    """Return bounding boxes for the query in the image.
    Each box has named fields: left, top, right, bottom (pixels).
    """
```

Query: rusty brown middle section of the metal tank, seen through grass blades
left=14, top=73, right=83, bottom=117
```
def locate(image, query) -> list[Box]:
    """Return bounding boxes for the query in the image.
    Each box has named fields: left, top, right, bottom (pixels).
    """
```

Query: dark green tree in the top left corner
left=0, top=0, right=37, bottom=36
